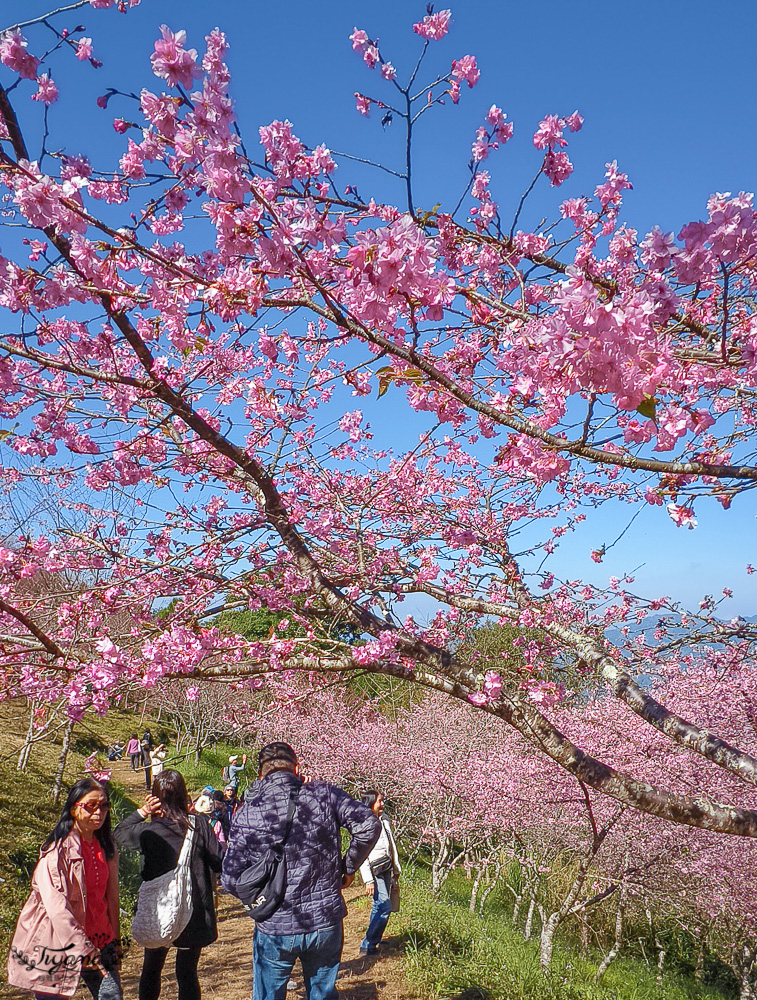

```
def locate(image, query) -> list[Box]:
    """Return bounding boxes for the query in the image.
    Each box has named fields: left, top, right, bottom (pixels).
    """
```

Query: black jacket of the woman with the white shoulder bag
left=113, top=810, right=221, bottom=948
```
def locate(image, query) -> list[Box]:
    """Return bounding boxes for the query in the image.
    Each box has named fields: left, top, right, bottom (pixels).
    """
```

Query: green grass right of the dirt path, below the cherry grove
left=401, top=865, right=725, bottom=1000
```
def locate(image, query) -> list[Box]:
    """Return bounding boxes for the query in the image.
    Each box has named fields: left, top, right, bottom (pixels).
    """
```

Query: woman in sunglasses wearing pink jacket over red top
left=8, top=778, right=121, bottom=1000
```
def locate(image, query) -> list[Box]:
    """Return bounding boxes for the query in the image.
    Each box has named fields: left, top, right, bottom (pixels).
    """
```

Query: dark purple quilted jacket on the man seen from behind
left=221, top=771, right=381, bottom=934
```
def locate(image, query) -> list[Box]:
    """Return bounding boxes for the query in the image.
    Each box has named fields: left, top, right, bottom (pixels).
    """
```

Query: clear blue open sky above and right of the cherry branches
left=0, top=0, right=757, bottom=615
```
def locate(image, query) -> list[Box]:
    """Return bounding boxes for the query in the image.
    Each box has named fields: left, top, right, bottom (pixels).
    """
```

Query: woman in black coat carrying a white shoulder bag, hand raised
left=113, top=768, right=221, bottom=1000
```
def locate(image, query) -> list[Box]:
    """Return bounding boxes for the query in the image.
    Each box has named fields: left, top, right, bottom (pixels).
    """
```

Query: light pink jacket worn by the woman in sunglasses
left=8, top=830, right=118, bottom=996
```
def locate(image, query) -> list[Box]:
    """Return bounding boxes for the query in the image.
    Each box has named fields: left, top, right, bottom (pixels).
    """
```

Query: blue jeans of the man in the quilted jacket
left=252, top=921, right=343, bottom=1000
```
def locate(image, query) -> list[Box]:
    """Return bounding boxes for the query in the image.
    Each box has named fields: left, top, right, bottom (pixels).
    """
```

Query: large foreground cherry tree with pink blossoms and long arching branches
left=0, top=0, right=757, bottom=837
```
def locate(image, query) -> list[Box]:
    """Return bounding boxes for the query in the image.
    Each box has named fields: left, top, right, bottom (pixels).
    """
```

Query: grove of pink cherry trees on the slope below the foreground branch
left=238, top=664, right=757, bottom=980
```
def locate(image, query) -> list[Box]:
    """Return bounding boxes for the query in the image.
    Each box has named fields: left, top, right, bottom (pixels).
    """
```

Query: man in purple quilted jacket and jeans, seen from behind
left=221, top=743, right=381, bottom=1000
